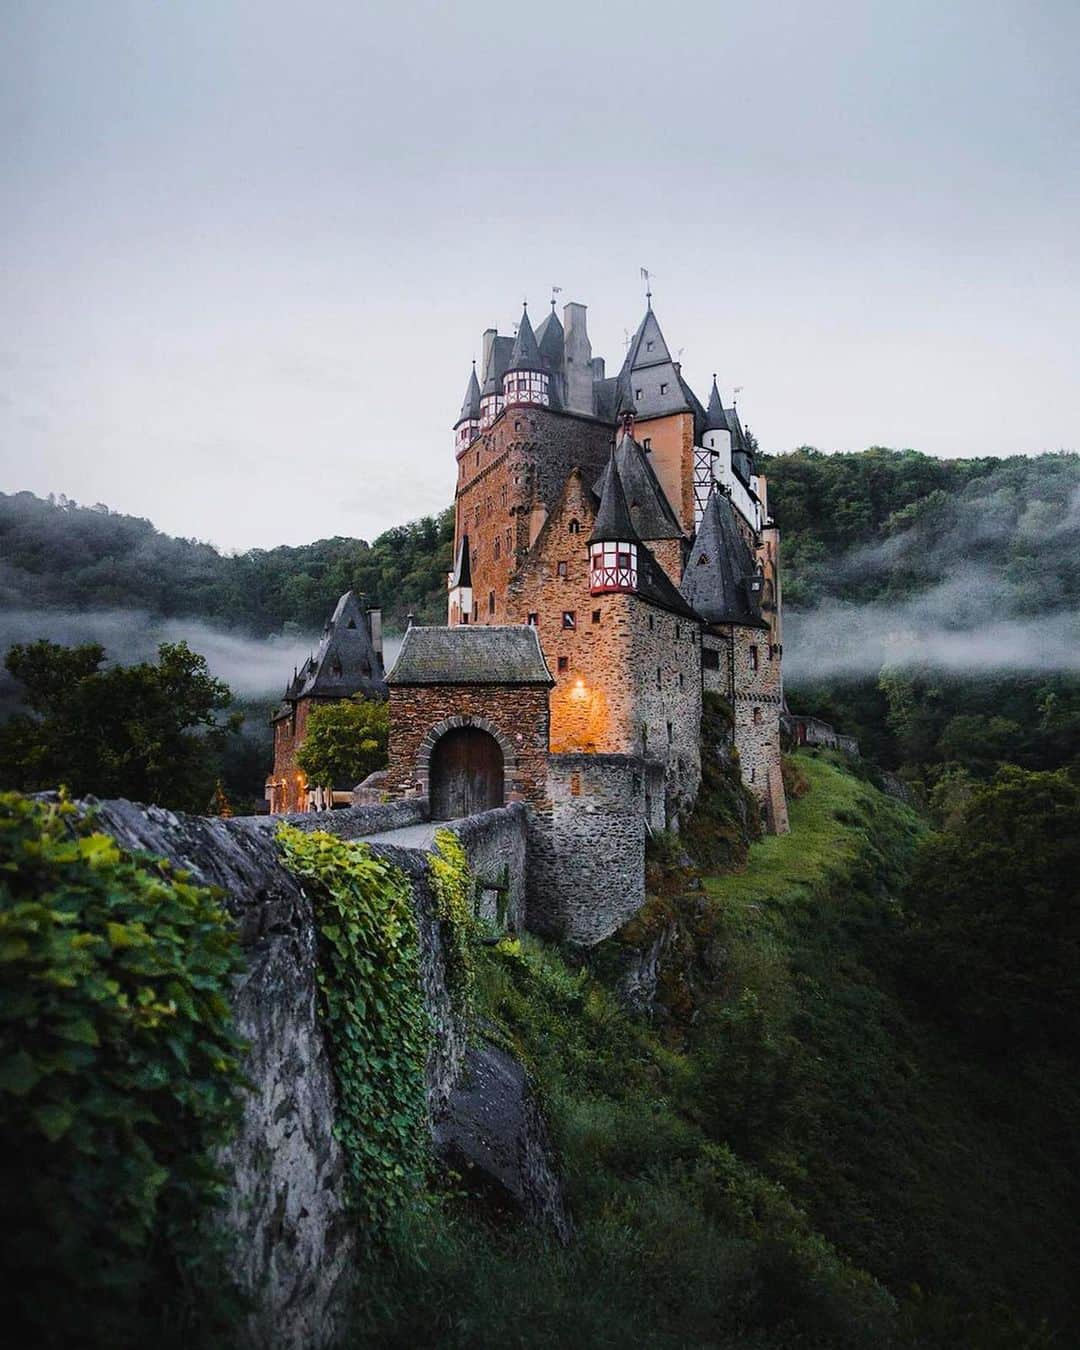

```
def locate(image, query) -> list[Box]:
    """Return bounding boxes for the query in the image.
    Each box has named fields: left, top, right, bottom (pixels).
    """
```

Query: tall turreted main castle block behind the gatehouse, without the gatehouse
left=434, top=304, right=787, bottom=830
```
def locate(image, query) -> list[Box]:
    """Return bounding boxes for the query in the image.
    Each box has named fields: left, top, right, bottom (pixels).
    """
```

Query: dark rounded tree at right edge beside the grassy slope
left=906, top=765, right=1080, bottom=1046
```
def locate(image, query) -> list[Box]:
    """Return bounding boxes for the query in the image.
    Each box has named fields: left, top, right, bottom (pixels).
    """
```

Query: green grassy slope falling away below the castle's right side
left=367, top=757, right=1067, bottom=1347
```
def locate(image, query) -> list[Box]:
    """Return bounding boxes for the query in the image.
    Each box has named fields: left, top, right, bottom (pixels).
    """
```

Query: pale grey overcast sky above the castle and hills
left=0, top=0, right=1080, bottom=548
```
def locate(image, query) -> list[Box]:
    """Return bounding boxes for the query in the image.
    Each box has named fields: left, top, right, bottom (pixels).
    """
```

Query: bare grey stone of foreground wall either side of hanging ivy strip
left=74, top=801, right=568, bottom=1350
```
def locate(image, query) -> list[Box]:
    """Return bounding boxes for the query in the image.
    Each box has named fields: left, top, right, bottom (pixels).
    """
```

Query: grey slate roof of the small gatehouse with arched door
left=387, top=624, right=555, bottom=687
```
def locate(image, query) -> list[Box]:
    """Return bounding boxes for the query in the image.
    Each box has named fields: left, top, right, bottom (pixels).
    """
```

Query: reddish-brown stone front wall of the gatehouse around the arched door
left=386, top=684, right=548, bottom=802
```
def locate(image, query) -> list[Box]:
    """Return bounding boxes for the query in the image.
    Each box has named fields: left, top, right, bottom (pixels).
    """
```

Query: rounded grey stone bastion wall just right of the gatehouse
left=527, top=755, right=649, bottom=946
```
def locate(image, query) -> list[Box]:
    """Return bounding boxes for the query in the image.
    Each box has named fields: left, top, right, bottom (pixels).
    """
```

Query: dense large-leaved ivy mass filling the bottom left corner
left=0, top=792, right=243, bottom=1346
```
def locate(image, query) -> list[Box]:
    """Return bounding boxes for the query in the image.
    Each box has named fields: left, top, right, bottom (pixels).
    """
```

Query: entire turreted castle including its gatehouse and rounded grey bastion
left=273, top=298, right=787, bottom=942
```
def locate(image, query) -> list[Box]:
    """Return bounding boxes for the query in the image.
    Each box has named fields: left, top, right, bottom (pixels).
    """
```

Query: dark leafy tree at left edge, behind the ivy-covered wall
left=0, top=641, right=238, bottom=811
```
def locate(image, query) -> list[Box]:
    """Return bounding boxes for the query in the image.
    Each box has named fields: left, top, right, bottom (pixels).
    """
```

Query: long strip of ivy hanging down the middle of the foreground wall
left=277, top=825, right=431, bottom=1237
